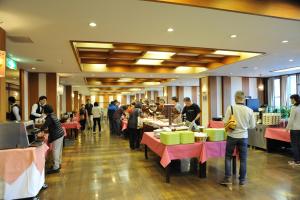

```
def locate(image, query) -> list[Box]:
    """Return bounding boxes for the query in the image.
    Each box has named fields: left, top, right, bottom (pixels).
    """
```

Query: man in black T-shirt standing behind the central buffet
left=181, top=97, right=201, bottom=125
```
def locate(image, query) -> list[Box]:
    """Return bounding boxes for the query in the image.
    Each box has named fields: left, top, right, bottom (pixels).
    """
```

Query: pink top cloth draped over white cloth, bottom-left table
left=0, top=144, right=48, bottom=183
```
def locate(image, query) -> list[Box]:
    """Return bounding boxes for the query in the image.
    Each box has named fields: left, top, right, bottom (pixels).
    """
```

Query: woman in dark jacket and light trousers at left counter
left=41, top=105, right=64, bottom=174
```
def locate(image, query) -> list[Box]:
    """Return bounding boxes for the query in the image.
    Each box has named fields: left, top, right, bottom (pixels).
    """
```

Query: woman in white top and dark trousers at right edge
left=286, top=94, right=300, bottom=166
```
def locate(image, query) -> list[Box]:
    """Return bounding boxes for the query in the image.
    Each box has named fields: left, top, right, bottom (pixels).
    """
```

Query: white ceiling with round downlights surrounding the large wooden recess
left=0, top=0, right=300, bottom=89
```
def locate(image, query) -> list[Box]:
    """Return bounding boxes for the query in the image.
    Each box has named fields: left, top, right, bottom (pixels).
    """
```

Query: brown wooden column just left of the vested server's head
left=28, top=72, right=39, bottom=115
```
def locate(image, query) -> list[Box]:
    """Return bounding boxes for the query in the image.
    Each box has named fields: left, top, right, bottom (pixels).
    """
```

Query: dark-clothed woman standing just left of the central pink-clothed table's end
left=128, top=103, right=141, bottom=150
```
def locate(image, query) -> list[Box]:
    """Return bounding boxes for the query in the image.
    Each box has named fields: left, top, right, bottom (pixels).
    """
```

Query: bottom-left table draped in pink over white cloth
left=0, top=144, right=48, bottom=199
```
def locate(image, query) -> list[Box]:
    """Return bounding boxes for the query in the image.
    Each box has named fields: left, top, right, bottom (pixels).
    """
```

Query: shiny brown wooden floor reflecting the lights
left=40, top=122, right=300, bottom=200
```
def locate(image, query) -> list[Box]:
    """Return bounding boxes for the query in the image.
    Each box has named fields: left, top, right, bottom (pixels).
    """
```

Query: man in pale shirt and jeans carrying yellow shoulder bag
left=220, top=91, right=256, bottom=185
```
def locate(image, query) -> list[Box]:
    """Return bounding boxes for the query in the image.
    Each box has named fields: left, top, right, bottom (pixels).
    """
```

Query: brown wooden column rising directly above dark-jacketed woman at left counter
left=46, top=73, right=57, bottom=113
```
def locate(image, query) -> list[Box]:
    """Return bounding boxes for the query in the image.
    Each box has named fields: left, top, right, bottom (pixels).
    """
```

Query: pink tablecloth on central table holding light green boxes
left=141, top=132, right=226, bottom=167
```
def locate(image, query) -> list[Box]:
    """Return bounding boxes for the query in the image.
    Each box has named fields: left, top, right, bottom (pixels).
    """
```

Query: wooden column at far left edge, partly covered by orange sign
left=0, top=27, right=8, bottom=122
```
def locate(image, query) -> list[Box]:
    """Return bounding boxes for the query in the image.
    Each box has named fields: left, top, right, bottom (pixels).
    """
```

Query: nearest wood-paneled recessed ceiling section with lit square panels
left=71, top=41, right=261, bottom=74
